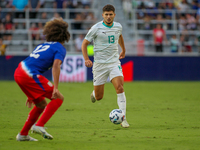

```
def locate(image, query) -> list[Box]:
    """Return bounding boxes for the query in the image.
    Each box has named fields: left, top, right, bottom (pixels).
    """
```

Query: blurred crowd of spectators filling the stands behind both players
left=0, top=0, right=200, bottom=52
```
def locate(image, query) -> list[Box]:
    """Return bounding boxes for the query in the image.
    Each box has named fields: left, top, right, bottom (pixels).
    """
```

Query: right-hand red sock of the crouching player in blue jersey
left=36, top=99, right=63, bottom=127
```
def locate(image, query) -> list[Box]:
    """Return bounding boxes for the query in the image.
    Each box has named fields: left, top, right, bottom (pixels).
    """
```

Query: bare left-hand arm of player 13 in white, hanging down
left=81, top=39, right=93, bottom=68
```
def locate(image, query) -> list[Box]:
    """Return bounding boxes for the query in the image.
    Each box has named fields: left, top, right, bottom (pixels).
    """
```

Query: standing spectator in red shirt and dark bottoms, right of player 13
left=153, top=24, right=167, bottom=52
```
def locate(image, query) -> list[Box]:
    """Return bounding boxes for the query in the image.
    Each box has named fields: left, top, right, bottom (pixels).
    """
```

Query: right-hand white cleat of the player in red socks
left=31, top=125, right=53, bottom=140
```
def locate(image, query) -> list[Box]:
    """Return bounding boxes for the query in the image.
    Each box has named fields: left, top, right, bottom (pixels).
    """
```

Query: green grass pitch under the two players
left=0, top=81, right=200, bottom=150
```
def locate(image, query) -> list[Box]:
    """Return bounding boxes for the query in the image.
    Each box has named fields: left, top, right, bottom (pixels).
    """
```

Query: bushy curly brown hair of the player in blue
left=43, top=18, right=70, bottom=43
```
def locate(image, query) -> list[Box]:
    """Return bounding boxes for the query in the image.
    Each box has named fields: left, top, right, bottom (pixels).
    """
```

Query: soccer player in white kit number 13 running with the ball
left=82, top=4, right=129, bottom=128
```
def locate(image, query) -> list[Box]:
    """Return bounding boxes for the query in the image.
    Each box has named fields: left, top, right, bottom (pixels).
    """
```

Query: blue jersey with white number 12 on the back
left=22, top=42, right=66, bottom=76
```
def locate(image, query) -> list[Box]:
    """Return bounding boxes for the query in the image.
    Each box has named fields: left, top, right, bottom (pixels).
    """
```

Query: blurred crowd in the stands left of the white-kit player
left=0, top=0, right=95, bottom=54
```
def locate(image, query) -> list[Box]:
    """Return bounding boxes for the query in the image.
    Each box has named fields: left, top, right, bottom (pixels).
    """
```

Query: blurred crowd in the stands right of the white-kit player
left=122, top=0, right=200, bottom=52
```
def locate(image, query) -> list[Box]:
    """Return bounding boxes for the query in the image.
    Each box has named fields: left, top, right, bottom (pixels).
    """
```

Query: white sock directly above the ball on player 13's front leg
left=117, top=92, right=126, bottom=119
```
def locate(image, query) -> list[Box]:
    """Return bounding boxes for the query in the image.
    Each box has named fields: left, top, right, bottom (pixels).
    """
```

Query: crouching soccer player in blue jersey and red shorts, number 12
left=14, top=19, right=70, bottom=141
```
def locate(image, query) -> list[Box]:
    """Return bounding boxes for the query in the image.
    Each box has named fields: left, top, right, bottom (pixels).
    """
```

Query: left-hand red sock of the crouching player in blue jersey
left=20, top=106, right=44, bottom=135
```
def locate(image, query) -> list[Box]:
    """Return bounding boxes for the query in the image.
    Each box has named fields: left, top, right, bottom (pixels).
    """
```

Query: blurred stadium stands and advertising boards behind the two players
left=0, top=0, right=200, bottom=82
